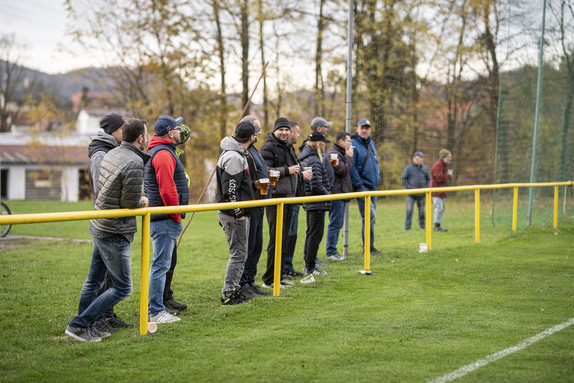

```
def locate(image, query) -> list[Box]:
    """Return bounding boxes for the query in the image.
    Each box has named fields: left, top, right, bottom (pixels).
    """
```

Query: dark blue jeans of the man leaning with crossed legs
left=70, top=235, right=133, bottom=328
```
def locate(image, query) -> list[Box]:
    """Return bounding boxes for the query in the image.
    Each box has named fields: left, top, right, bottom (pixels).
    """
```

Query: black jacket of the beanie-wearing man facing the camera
left=261, top=133, right=304, bottom=198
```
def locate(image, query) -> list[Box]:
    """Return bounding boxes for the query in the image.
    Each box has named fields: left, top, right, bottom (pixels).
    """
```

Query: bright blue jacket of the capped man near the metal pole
left=351, top=133, right=381, bottom=190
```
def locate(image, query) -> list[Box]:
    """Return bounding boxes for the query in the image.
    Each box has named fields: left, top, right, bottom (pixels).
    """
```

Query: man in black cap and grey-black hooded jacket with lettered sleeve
left=217, top=122, right=259, bottom=306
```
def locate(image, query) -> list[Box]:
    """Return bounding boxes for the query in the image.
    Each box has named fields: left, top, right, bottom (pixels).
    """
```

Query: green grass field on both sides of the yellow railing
left=0, top=199, right=574, bottom=382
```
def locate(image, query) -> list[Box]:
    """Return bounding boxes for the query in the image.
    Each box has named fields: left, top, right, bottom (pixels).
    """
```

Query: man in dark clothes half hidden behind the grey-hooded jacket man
left=239, top=116, right=271, bottom=298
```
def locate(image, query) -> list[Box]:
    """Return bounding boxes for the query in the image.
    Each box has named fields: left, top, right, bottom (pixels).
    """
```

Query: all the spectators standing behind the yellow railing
left=65, top=113, right=452, bottom=342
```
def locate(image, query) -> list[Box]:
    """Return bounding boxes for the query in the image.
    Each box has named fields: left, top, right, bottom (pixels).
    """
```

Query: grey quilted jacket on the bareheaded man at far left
left=91, top=142, right=149, bottom=234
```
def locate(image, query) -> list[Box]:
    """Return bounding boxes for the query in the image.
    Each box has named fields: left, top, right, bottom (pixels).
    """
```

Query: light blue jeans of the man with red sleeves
left=149, top=219, right=182, bottom=316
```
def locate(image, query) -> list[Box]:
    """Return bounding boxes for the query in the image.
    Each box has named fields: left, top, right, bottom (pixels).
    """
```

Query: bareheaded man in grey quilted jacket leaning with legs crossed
left=65, top=119, right=149, bottom=342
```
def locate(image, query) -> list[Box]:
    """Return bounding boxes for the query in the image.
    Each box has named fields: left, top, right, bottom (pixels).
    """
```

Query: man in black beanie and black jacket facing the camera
left=261, top=117, right=312, bottom=288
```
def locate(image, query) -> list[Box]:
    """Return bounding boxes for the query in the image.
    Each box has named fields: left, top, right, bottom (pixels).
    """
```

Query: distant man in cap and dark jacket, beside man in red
left=401, top=152, right=430, bottom=230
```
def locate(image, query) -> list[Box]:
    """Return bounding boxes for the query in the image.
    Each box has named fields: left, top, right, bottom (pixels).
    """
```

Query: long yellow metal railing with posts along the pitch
left=0, top=181, right=574, bottom=335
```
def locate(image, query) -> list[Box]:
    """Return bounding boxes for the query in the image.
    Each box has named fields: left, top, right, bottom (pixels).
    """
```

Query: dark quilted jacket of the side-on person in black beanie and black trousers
left=299, top=146, right=331, bottom=210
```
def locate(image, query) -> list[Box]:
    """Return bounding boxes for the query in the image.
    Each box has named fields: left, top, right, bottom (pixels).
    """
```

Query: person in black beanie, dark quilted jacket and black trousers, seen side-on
left=299, top=132, right=332, bottom=275
